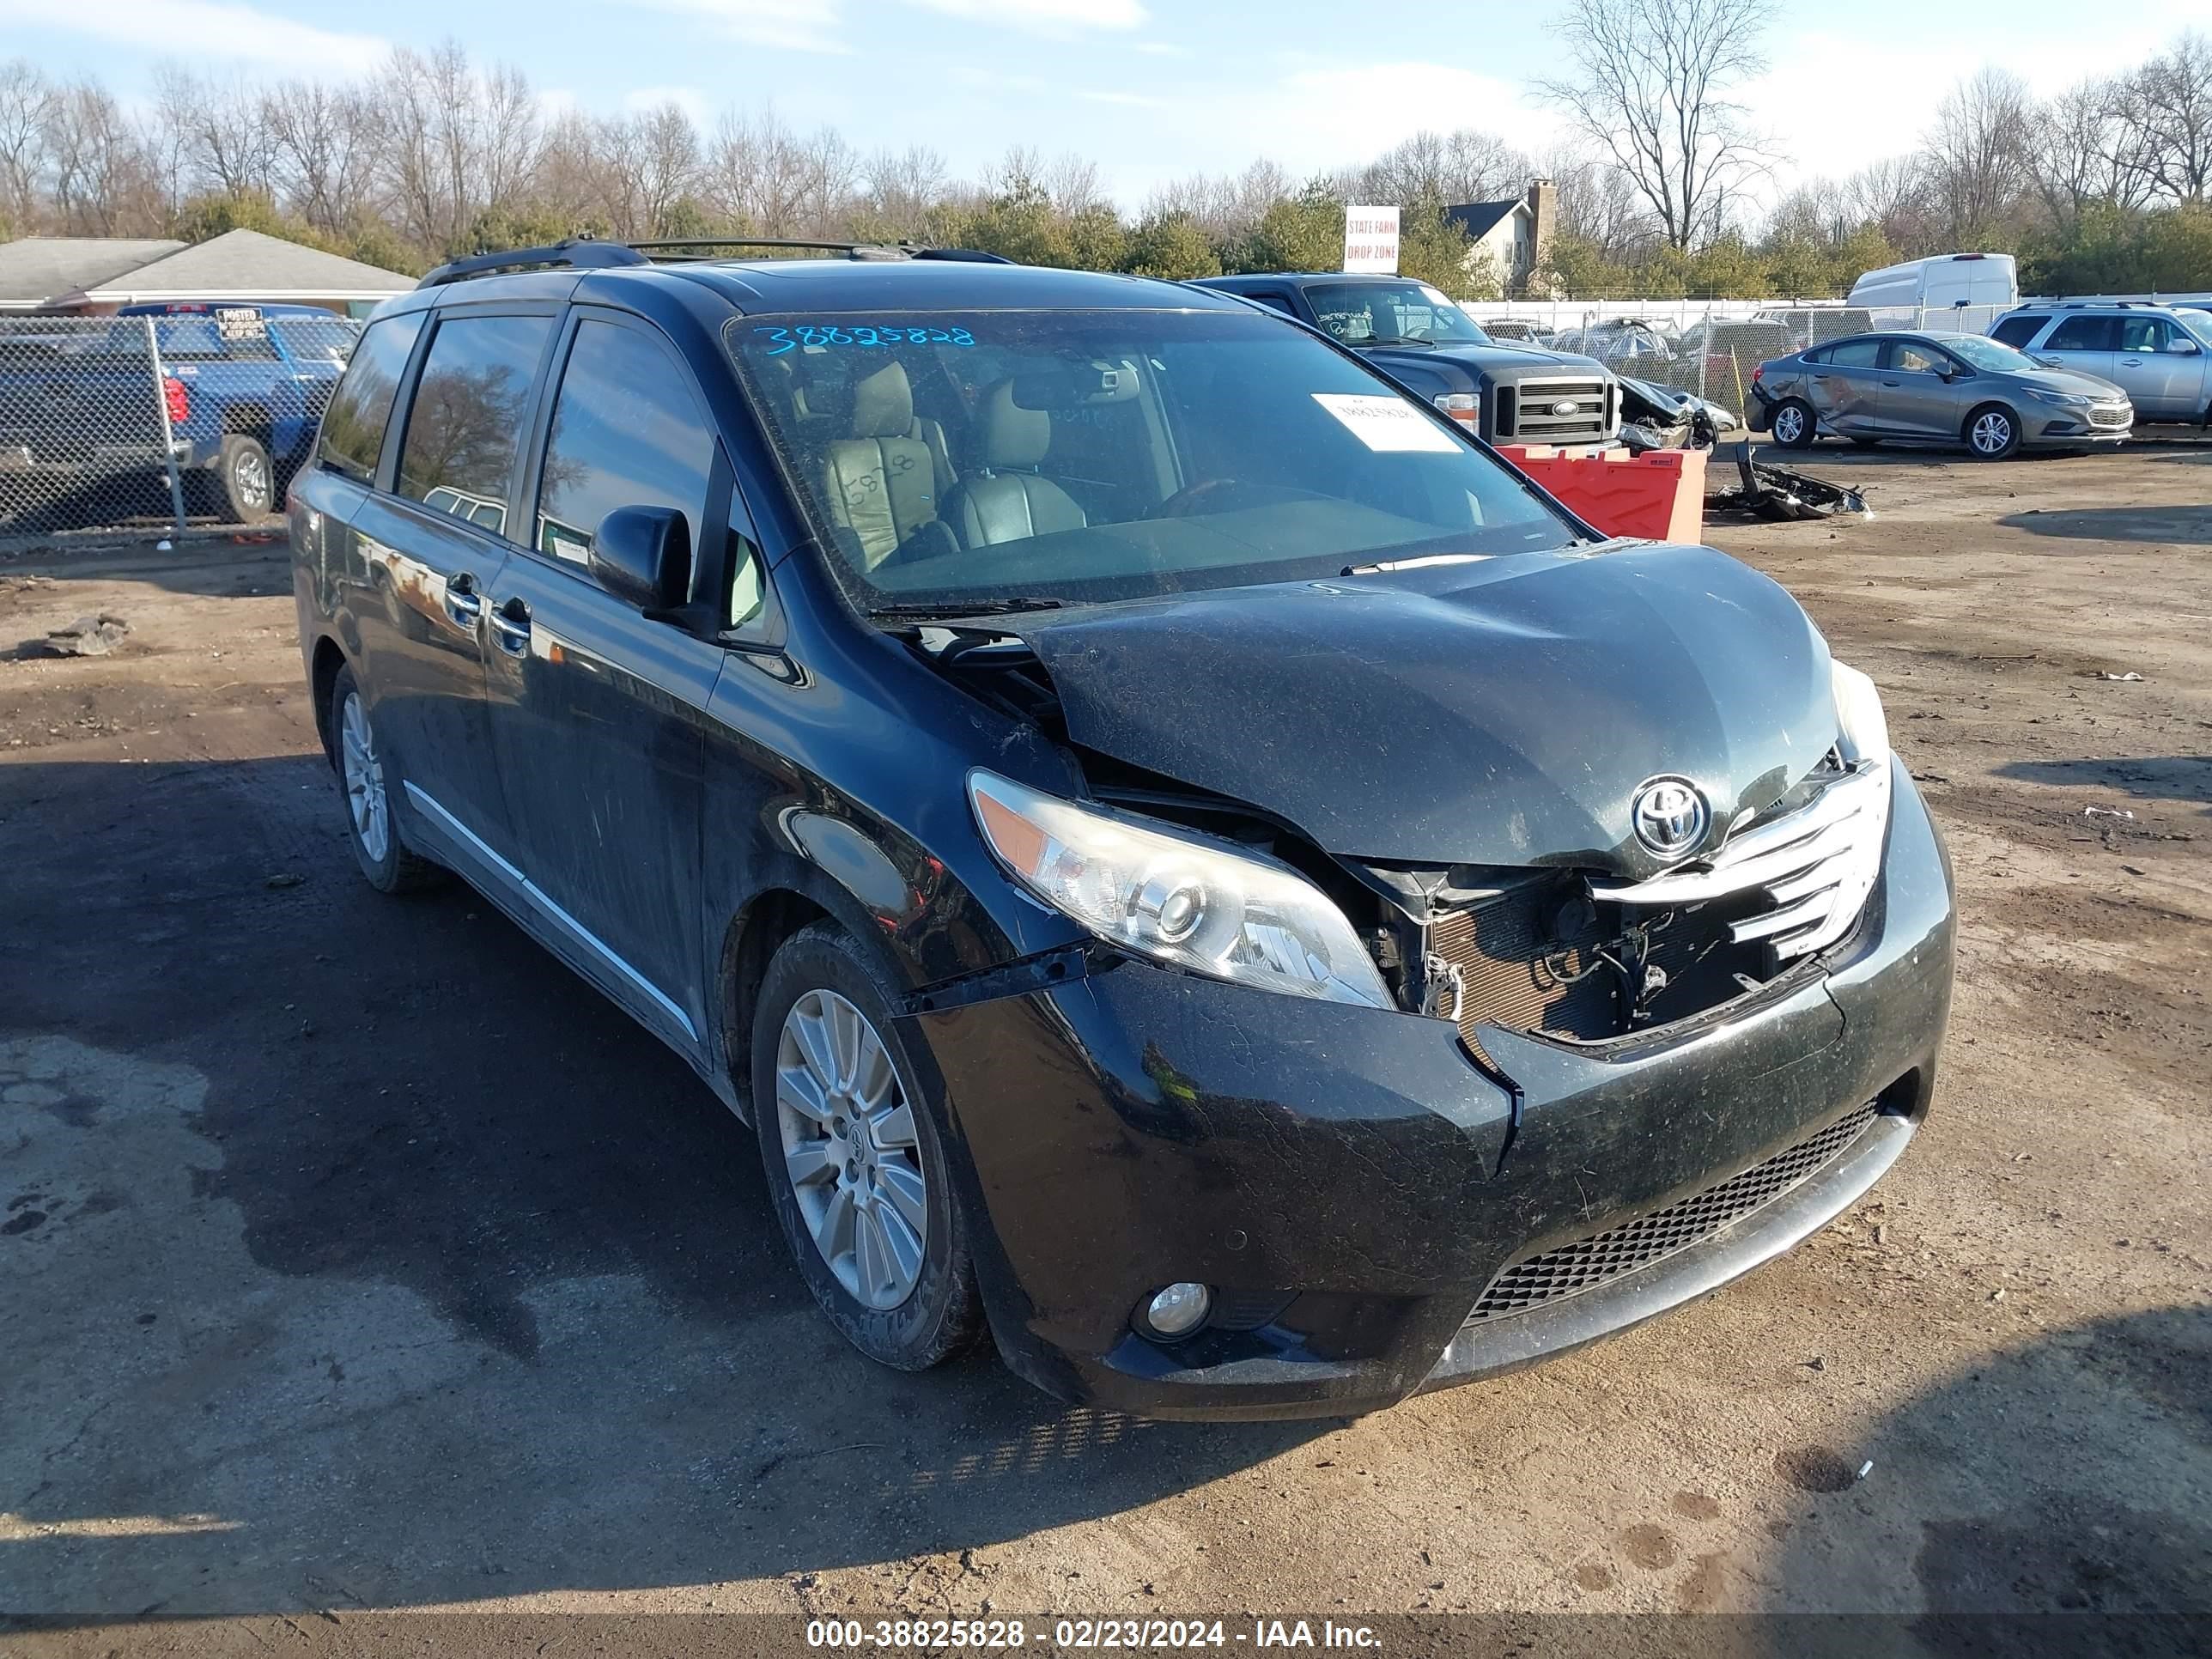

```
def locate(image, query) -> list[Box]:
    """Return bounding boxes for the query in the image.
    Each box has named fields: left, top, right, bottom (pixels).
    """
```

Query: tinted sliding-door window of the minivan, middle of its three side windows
left=396, top=316, right=553, bottom=533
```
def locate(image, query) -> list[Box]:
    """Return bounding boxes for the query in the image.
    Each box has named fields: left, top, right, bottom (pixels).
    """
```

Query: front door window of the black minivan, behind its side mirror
left=532, top=321, right=714, bottom=564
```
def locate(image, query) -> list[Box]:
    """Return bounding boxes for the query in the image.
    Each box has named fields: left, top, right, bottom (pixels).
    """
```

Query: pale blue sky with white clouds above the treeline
left=0, top=0, right=2212, bottom=208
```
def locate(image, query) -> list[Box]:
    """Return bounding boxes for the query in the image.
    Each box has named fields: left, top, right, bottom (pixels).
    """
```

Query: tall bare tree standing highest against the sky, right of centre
left=1541, top=0, right=1771, bottom=248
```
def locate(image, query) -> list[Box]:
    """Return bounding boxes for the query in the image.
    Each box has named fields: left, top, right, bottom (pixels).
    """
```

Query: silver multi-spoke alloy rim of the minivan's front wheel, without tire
left=776, top=988, right=929, bottom=1312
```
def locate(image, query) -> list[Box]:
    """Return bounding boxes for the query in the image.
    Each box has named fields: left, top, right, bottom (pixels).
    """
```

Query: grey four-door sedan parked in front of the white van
left=1745, top=334, right=2135, bottom=460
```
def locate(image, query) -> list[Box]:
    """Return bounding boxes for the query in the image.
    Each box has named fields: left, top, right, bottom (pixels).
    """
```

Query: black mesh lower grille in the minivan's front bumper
left=1467, top=1102, right=1875, bottom=1325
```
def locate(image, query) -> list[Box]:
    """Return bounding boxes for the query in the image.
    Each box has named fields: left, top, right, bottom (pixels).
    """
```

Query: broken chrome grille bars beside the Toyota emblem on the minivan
left=1590, top=759, right=1889, bottom=963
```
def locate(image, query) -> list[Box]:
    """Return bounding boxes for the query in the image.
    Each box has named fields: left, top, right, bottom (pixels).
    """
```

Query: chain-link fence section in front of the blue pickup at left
left=0, top=305, right=361, bottom=538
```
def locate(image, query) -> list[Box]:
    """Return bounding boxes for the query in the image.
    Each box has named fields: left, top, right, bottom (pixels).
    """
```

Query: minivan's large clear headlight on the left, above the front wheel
left=969, top=769, right=1394, bottom=1009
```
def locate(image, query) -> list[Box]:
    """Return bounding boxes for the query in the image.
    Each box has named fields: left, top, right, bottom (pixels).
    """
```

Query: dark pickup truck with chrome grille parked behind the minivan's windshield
left=1197, top=272, right=1621, bottom=445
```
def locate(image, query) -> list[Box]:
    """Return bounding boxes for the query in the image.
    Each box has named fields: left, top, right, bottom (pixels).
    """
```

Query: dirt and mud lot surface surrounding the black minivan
left=0, top=445, right=2212, bottom=1650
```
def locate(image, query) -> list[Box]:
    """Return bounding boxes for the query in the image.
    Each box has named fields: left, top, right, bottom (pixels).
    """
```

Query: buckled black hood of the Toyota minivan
left=1000, top=544, right=1836, bottom=876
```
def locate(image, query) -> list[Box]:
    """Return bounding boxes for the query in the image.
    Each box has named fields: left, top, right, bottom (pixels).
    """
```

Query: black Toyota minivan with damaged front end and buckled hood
left=289, top=243, right=1954, bottom=1418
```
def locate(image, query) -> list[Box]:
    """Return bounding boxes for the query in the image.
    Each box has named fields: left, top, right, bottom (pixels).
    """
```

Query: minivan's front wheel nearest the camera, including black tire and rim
left=752, top=922, right=982, bottom=1371
